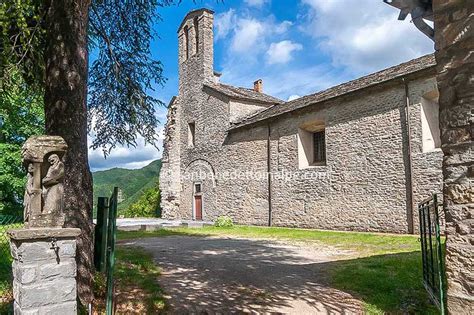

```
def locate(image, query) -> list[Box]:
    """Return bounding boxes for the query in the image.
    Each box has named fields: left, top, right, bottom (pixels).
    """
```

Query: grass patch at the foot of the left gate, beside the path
left=94, top=246, right=166, bottom=314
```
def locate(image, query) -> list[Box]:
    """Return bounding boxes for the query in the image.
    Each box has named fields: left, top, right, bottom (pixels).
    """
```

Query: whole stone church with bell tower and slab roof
left=160, top=9, right=443, bottom=233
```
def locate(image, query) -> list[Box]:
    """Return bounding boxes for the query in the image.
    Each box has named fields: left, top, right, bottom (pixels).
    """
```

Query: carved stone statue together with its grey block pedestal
left=10, top=136, right=81, bottom=315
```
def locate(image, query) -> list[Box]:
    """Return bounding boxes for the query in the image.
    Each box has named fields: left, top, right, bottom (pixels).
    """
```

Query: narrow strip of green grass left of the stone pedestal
left=0, top=215, right=23, bottom=314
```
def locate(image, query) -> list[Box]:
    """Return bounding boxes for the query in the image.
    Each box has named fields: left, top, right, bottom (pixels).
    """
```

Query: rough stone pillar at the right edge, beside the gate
left=433, top=0, right=474, bottom=314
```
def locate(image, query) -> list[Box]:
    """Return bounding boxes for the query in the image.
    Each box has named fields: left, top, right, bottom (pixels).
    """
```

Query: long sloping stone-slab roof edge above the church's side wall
left=230, top=54, right=436, bottom=130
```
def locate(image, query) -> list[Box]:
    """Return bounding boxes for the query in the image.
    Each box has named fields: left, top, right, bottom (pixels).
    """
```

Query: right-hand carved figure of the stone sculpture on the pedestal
left=42, top=154, right=64, bottom=220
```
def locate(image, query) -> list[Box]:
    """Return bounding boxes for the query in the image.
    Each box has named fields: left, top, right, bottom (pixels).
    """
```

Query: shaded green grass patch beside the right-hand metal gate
left=329, top=252, right=439, bottom=314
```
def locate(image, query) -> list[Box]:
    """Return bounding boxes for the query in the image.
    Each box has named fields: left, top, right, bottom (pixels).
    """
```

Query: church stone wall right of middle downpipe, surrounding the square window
left=258, top=79, right=442, bottom=233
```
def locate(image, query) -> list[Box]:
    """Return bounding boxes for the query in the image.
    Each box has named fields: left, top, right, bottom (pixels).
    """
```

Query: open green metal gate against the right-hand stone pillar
left=418, top=194, right=446, bottom=314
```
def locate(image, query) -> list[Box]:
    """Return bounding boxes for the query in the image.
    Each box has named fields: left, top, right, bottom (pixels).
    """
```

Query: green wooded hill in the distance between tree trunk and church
left=92, top=160, right=161, bottom=213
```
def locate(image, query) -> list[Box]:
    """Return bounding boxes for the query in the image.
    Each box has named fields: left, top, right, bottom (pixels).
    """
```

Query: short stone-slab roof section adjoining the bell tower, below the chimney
left=204, top=83, right=283, bottom=105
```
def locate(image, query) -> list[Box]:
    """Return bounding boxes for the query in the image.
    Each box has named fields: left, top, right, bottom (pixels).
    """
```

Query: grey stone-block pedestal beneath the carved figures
left=8, top=228, right=81, bottom=315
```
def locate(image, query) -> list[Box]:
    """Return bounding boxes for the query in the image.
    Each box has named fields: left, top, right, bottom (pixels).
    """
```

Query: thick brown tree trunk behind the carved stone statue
left=44, top=0, right=93, bottom=305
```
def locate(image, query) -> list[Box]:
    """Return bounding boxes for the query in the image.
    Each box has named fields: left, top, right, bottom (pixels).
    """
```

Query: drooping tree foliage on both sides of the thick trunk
left=0, top=0, right=175, bottom=154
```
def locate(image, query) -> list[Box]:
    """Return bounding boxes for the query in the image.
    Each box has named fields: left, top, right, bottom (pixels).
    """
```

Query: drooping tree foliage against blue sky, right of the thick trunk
left=89, top=1, right=166, bottom=153
